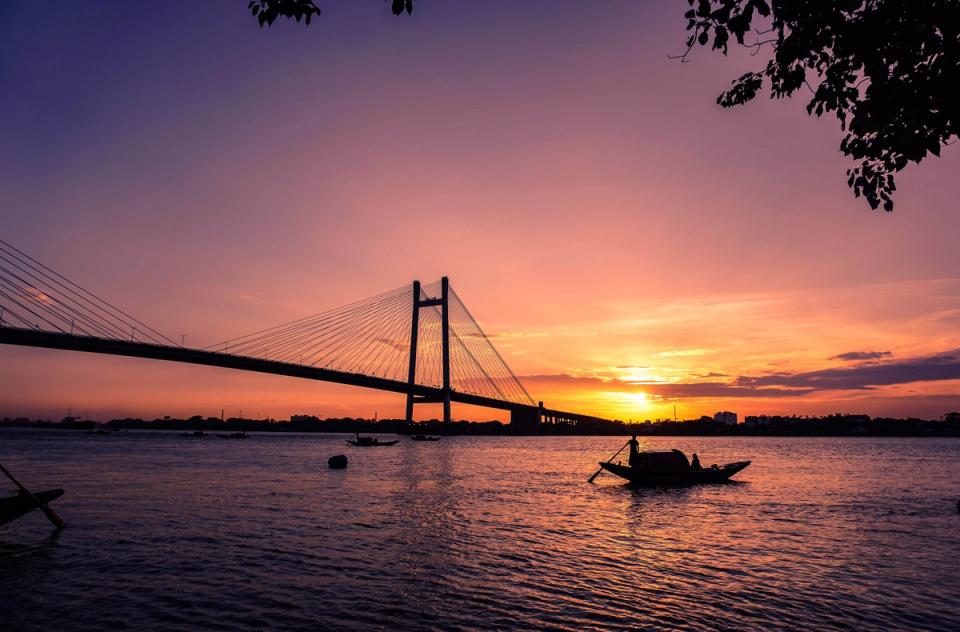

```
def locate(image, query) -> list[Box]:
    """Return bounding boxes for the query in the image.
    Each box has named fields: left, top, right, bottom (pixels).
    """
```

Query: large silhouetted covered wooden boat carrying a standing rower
left=600, top=450, right=750, bottom=485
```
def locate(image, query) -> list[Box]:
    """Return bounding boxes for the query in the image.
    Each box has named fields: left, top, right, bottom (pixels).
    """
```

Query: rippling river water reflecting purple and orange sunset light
left=0, top=429, right=960, bottom=630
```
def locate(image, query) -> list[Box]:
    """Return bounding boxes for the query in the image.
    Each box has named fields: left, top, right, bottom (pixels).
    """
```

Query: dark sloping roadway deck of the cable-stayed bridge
left=0, top=326, right=595, bottom=428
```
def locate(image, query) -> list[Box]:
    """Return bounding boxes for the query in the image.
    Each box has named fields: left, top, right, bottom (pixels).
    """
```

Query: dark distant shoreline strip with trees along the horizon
left=0, top=413, right=960, bottom=437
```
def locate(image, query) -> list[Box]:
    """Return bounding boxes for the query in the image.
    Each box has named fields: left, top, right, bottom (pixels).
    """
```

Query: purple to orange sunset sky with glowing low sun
left=0, top=0, right=960, bottom=420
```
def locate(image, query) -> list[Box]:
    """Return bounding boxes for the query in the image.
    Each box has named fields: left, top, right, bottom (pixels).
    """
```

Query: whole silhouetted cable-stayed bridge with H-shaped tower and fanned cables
left=0, top=240, right=612, bottom=432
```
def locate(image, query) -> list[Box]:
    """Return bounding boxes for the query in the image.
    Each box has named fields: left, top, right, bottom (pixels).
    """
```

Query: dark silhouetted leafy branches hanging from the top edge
left=248, top=0, right=960, bottom=211
